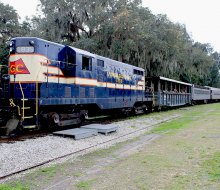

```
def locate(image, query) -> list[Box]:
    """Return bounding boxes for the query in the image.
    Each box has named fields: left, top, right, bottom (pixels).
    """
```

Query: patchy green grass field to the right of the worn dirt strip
left=88, top=104, right=220, bottom=190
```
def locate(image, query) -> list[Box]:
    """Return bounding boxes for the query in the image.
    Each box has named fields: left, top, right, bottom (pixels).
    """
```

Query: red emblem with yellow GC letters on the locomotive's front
left=10, top=58, right=30, bottom=75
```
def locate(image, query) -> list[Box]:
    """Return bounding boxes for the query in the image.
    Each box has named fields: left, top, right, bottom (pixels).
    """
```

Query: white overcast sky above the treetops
left=0, top=0, right=220, bottom=52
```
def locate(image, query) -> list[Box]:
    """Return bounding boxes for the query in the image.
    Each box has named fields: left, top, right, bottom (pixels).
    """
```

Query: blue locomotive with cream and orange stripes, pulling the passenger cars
left=0, top=37, right=152, bottom=134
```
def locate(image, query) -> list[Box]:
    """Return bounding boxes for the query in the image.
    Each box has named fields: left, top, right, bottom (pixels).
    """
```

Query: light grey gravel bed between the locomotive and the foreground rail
left=0, top=114, right=178, bottom=180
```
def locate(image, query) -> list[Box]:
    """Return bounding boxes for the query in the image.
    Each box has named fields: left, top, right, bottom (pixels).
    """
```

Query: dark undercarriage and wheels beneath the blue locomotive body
left=0, top=99, right=150, bottom=136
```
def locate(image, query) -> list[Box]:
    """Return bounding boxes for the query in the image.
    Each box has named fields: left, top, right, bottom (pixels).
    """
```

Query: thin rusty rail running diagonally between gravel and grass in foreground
left=0, top=116, right=180, bottom=181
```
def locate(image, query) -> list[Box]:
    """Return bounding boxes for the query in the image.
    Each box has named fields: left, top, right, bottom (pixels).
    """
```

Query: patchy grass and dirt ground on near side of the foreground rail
left=0, top=104, right=220, bottom=190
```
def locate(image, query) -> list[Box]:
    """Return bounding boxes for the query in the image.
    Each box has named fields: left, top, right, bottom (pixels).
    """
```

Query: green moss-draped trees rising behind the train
left=0, top=0, right=220, bottom=87
